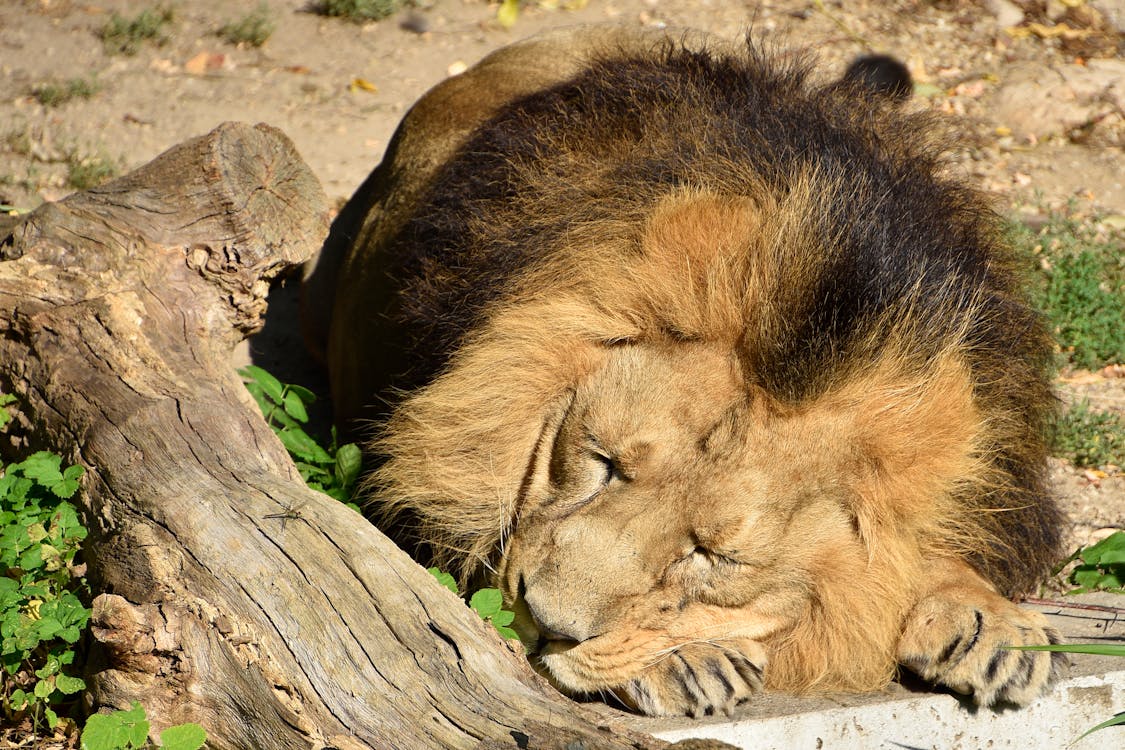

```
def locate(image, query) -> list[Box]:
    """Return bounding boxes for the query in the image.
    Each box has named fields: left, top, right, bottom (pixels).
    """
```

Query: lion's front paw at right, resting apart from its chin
left=898, top=593, right=1068, bottom=705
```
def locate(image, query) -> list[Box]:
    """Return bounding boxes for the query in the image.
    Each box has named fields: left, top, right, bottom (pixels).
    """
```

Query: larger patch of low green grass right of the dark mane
left=1009, top=213, right=1125, bottom=369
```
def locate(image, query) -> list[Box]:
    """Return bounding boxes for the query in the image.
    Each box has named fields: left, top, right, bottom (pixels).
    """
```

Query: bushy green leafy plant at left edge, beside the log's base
left=0, top=452, right=90, bottom=729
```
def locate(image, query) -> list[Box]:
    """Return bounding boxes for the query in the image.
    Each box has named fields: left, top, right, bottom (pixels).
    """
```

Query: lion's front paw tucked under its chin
left=618, top=639, right=766, bottom=717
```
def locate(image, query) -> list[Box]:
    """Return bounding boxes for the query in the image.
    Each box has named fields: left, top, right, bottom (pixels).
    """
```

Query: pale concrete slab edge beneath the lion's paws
left=621, top=595, right=1125, bottom=750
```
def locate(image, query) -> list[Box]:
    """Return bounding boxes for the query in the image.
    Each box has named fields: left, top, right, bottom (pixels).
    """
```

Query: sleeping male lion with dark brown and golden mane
left=306, top=28, right=1063, bottom=716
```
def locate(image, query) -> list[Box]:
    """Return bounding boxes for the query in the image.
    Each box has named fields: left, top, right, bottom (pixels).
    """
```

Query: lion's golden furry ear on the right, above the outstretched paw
left=829, top=354, right=986, bottom=548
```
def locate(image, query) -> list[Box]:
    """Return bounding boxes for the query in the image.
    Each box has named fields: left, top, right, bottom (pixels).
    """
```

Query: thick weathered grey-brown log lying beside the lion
left=0, top=124, right=663, bottom=748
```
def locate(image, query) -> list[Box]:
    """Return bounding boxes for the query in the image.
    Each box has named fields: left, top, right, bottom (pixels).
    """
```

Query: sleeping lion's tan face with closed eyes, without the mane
left=500, top=342, right=863, bottom=713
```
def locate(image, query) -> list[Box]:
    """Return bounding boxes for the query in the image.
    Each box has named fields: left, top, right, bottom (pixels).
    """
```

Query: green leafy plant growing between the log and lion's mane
left=239, top=364, right=363, bottom=510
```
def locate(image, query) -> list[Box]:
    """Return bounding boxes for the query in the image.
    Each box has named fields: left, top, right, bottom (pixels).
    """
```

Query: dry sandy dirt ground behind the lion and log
left=0, top=0, right=1125, bottom=629
